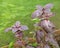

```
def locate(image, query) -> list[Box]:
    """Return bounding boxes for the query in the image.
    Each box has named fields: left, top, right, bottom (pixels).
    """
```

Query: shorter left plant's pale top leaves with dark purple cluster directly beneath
left=5, top=21, right=28, bottom=39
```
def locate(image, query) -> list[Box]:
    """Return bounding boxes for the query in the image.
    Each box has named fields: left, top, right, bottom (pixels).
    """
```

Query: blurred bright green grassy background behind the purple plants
left=0, top=0, right=60, bottom=47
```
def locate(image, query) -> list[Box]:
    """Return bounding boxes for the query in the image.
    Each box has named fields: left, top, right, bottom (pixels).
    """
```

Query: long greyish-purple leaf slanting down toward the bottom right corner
left=45, top=33, right=59, bottom=48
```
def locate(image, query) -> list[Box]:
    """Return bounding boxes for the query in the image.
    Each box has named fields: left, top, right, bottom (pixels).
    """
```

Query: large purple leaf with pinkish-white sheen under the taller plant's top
left=39, top=20, right=55, bottom=33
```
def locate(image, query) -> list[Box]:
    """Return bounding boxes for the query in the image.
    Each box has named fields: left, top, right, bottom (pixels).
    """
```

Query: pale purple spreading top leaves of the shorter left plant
left=5, top=21, right=28, bottom=33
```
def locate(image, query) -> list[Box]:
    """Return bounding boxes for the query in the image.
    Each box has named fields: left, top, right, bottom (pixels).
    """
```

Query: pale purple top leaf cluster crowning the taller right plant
left=32, top=3, right=54, bottom=18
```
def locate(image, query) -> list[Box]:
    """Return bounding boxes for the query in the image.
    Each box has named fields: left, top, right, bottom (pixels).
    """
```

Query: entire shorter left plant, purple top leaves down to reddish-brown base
left=5, top=21, right=28, bottom=48
